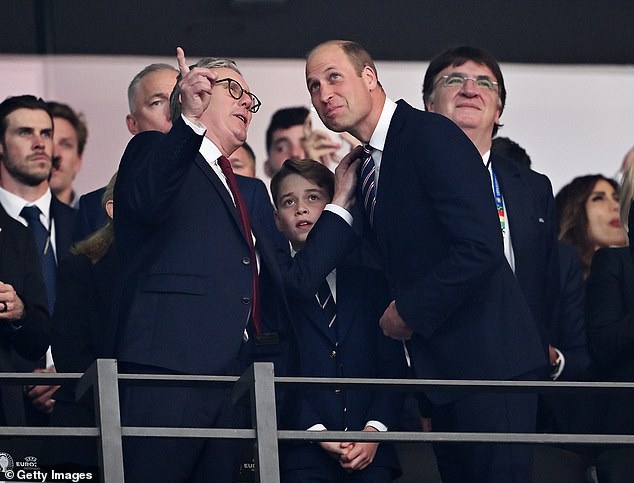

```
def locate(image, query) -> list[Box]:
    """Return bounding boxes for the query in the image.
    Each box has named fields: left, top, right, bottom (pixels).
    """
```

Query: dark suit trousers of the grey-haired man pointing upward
left=120, top=363, right=247, bottom=483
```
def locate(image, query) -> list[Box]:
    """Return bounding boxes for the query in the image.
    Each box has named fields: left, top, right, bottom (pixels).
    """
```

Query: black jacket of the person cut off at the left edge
left=0, top=206, right=50, bottom=426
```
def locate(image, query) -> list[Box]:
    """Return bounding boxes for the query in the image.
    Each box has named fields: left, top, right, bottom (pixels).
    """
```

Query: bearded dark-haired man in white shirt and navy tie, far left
left=0, top=95, right=75, bottom=424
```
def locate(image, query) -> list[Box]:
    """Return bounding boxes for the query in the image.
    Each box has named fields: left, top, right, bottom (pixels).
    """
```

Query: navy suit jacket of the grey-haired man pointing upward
left=114, top=118, right=355, bottom=374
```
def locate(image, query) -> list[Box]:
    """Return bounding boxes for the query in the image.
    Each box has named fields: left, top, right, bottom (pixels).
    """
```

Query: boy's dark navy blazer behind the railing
left=280, top=264, right=406, bottom=477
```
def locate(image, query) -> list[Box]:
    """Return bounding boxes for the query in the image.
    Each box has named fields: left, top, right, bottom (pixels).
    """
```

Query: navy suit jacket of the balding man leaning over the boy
left=366, top=101, right=546, bottom=404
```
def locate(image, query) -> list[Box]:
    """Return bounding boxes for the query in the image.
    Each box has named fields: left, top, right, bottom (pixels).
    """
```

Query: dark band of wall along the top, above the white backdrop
left=0, top=0, right=634, bottom=64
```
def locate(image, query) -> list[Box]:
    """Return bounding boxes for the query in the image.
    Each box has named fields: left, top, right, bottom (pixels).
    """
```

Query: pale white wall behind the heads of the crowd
left=0, top=55, right=634, bottom=199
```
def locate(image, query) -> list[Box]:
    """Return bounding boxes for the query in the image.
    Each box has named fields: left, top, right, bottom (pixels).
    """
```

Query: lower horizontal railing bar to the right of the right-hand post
left=277, top=430, right=634, bottom=445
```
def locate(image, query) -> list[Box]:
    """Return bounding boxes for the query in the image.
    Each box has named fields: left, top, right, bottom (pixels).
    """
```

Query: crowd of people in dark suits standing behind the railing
left=0, top=40, right=634, bottom=483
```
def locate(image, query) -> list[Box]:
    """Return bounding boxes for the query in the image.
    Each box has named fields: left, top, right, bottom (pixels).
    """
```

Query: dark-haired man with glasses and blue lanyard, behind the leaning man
left=423, top=47, right=565, bottom=377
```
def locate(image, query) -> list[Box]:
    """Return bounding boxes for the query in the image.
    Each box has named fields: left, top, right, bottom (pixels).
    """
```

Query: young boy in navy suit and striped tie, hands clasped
left=271, top=159, right=406, bottom=483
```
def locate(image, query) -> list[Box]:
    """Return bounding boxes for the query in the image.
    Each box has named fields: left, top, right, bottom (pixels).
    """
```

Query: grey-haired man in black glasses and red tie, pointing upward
left=114, top=48, right=358, bottom=482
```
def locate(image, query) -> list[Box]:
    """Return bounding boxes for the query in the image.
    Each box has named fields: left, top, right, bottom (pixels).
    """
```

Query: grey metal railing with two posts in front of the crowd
left=0, top=359, right=634, bottom=483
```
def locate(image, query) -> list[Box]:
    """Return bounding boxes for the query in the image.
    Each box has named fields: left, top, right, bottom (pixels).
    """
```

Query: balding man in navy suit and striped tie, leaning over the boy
left=306, top=41, right=545, bottom=483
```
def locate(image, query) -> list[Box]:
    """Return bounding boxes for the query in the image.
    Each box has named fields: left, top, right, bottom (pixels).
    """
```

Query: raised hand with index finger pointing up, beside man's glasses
left=176, top=47, right=218, bottom=124
